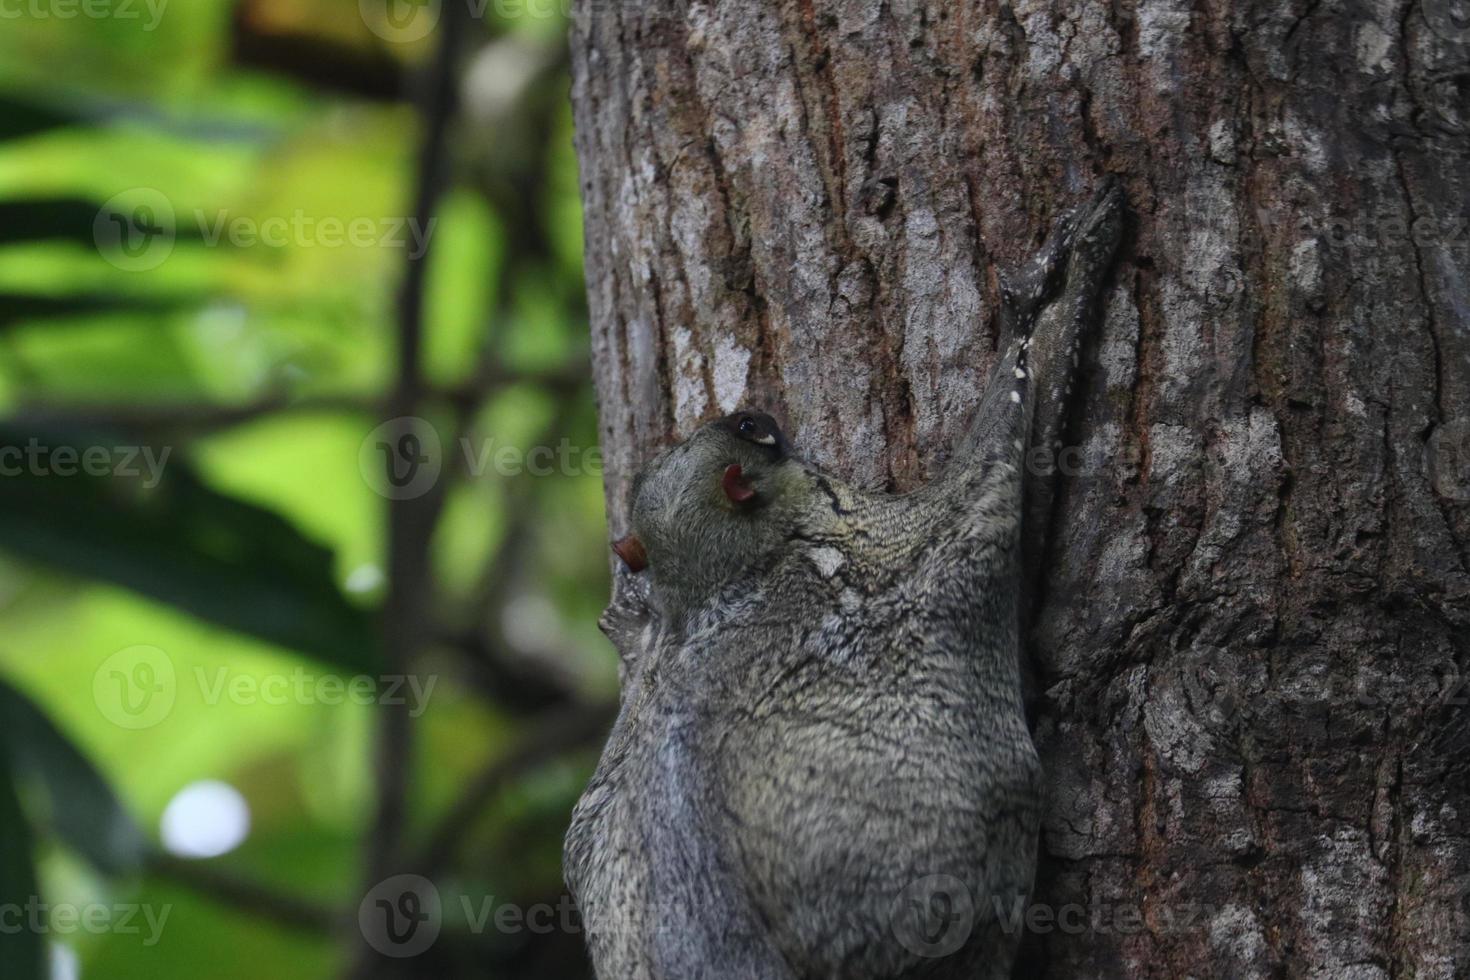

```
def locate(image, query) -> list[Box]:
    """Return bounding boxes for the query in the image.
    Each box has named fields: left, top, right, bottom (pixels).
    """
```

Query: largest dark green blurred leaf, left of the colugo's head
left=0, top=425, right=378, bottom=673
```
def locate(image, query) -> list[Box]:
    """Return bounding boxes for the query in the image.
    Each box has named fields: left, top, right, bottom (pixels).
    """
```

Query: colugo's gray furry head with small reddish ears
left=613, top=411, right=801, bottom=608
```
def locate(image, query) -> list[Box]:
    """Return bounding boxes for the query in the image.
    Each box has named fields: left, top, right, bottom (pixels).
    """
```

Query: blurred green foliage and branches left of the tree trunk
left=0, top=0, right=617, bottom=980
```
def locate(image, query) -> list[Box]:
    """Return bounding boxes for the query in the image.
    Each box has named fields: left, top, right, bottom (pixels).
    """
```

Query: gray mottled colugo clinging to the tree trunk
left=566, top=185, right=1122, bottom=980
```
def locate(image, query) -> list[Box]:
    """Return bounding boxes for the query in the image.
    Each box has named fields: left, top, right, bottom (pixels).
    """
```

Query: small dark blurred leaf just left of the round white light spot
left=0, top=680, right=147, bottom=874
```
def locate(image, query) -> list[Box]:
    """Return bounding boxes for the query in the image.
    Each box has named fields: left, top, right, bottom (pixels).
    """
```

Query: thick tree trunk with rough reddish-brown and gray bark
left=572, top=0, right=1470, bottom=980
